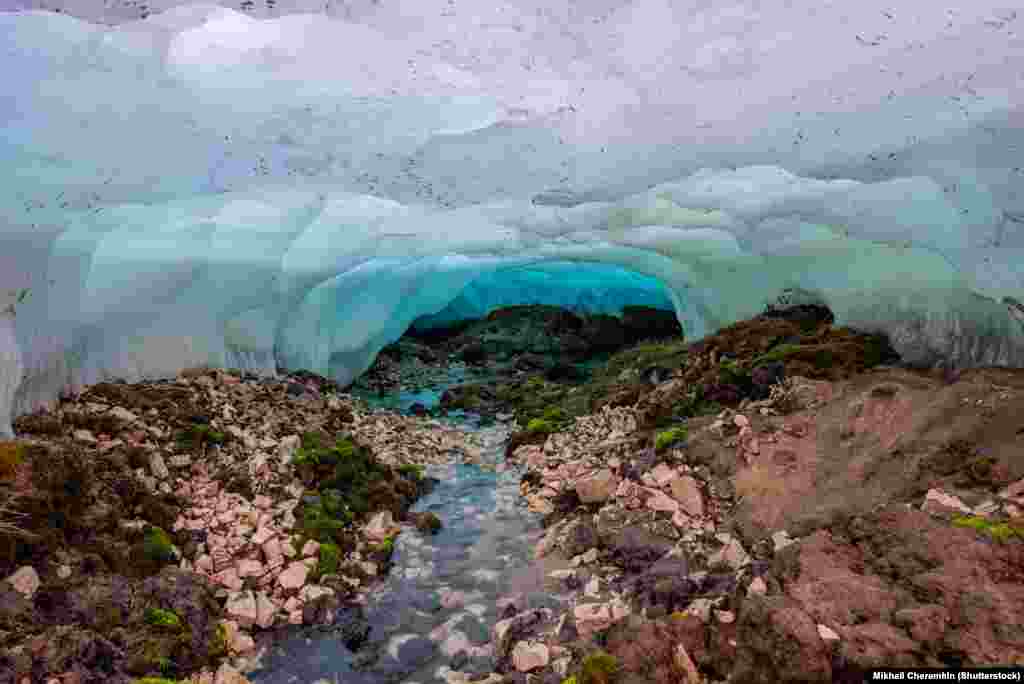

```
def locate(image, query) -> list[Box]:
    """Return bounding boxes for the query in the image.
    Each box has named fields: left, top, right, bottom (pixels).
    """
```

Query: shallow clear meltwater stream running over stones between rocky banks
left=249, top=411, right=560, bottom=684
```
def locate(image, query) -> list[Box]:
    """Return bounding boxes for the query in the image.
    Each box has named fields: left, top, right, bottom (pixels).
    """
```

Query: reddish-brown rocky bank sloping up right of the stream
left=483, top=309, right=1024, bottom=684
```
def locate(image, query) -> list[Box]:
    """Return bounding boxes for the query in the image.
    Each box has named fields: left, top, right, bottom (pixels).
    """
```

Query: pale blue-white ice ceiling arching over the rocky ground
left=0, top=0, right=1024, bottom=433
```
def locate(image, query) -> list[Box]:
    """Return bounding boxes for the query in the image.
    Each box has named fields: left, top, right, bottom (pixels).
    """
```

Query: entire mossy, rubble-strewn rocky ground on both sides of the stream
left=0, top=306, right=1024, bottom=684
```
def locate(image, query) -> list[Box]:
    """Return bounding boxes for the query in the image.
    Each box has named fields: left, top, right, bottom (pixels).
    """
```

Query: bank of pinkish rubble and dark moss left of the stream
left=0, top=370, right=479, bottom=684
